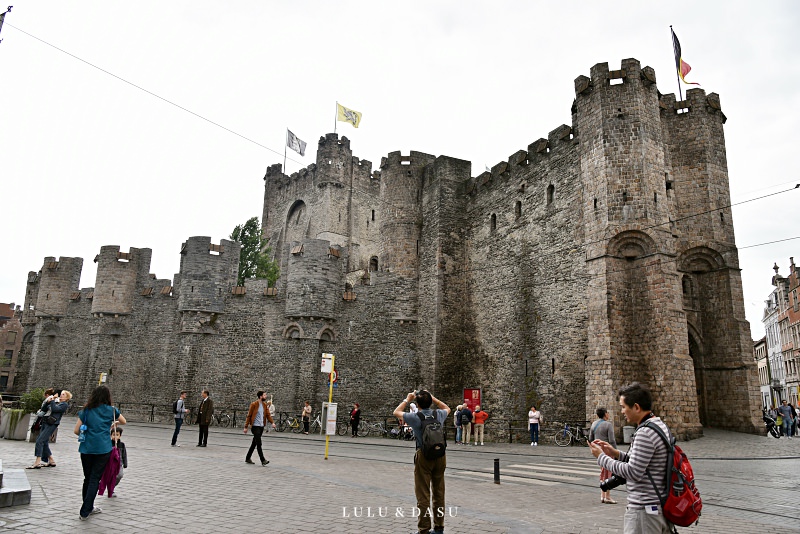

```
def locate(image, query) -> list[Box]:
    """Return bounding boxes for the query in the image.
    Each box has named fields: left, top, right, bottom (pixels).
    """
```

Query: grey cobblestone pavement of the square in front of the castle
left=0, top=418, right=800, bottom=534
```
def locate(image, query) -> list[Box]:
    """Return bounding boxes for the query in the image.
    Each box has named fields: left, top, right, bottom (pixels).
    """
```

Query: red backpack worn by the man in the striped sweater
left=644, top=422, right=703, bottom=532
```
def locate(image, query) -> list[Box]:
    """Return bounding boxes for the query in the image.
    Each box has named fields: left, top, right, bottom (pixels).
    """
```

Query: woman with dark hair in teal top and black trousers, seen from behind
left=74, top=386, right=125, bottom=521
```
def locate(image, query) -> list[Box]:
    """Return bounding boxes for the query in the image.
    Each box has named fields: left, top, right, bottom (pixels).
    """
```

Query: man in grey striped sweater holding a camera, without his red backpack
left=589, top=382, right=671, bottom=534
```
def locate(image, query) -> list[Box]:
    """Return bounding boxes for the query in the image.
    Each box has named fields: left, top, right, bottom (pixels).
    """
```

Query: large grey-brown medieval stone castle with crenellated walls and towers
left=12, top=59, right=761, bottom=438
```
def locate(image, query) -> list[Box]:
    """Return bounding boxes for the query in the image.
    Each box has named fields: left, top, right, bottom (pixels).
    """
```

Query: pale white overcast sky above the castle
left=0, top=0, right=800, bottom=338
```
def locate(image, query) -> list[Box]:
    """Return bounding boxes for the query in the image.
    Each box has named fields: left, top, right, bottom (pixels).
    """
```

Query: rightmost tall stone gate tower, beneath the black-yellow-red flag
left=661, top=89, right=761, bottom=432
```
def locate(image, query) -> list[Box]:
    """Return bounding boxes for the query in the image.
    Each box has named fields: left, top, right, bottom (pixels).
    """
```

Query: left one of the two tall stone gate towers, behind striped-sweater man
left=575, top=59, right=701, bottom=436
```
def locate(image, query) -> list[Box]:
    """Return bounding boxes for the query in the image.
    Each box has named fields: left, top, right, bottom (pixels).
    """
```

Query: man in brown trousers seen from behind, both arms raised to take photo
left=394, top=389, right=450, bottom=534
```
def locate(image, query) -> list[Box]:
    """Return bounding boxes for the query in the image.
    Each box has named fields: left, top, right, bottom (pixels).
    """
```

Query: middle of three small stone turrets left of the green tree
left=92, top=245, right=152, bottom=315
